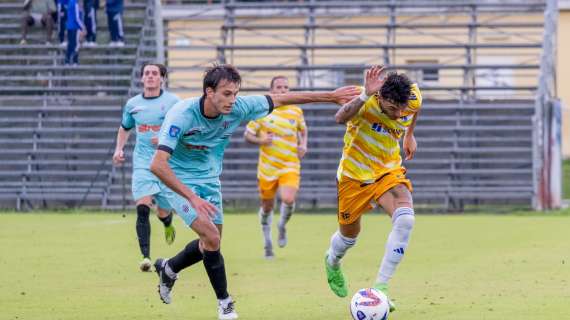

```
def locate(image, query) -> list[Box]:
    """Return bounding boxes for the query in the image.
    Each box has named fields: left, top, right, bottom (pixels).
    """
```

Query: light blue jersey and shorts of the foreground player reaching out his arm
left=158, top=96, right=273, bottom=226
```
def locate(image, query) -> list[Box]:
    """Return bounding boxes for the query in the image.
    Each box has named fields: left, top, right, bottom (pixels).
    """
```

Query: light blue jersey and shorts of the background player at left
left=121, top=91, right=180, bottom=202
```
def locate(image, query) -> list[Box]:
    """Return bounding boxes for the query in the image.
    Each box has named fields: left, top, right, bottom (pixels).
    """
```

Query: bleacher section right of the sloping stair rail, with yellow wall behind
left=163, top=0, right=550, bottom=211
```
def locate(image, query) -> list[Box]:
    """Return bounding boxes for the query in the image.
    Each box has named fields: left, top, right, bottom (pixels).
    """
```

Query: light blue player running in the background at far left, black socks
left=113, top=63, right=180, bottom=271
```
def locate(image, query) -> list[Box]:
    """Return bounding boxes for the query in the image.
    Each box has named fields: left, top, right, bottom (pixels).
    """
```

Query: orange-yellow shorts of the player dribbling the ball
left=337, top=167, right=412, bottom=225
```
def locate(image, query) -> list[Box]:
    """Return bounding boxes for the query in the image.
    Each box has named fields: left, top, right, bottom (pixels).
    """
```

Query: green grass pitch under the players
left=0, top=212, right=570, bottom=320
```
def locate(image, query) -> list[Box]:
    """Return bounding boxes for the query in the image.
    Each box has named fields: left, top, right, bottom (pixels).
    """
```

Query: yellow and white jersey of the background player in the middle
left=246, top=105, right=307, bottom=181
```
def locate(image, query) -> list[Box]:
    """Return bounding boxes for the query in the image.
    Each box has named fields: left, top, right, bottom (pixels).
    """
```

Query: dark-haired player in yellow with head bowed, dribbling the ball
left=325, top=66, right=422, bottom=311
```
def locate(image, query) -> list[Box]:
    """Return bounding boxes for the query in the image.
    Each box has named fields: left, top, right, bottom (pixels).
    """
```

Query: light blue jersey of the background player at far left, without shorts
left=121, top=90, right=180, bottom=169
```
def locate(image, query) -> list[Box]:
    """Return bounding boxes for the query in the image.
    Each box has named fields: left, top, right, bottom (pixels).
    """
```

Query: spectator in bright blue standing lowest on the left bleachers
left=65, top=0, right=85, bottom=65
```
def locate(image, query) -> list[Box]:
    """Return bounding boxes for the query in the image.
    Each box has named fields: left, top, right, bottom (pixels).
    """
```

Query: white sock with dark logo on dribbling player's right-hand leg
left=376, top=207, right=415, bottom=283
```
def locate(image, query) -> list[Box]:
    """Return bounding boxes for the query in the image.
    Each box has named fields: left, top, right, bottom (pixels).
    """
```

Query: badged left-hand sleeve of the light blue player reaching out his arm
left=158, top=101, right=190, bottom=154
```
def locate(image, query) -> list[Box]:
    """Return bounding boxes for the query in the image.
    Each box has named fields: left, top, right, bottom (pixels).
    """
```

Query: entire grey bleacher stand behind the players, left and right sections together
left=0, top=0, right=556, bottom=211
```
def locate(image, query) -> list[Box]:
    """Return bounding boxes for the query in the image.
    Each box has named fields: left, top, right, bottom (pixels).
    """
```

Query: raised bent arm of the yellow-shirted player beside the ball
left=335, top=66, right=384, bottom=124
